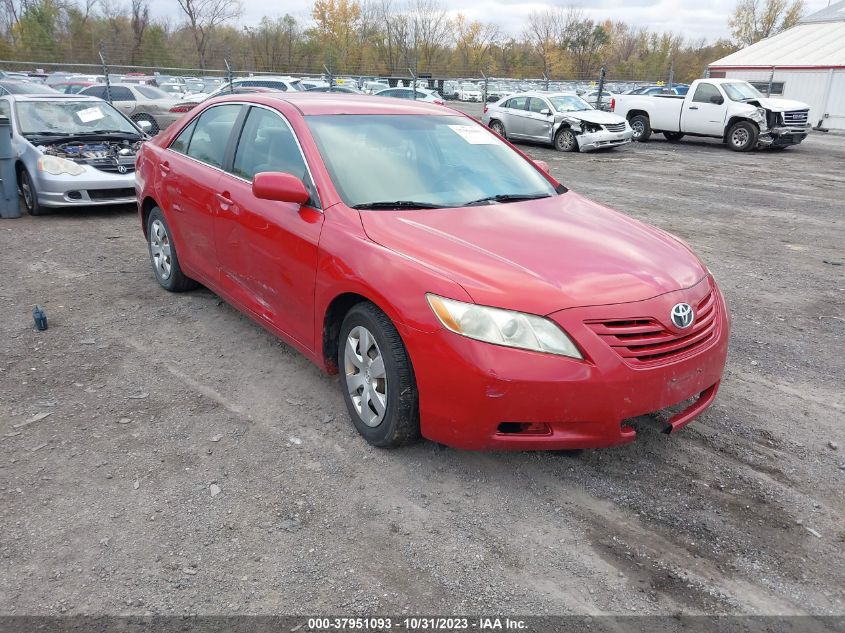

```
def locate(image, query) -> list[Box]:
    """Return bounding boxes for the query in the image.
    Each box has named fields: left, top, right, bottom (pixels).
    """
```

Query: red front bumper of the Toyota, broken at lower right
left=403, top=279, right=729, bottom=450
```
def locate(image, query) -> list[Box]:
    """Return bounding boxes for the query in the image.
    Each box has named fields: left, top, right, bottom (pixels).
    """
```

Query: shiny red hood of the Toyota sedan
left=360, top=191, right=707, bottom=314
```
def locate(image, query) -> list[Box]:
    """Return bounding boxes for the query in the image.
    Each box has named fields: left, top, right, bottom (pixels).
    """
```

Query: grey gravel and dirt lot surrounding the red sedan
left=0, top=111, right=845, bottom=614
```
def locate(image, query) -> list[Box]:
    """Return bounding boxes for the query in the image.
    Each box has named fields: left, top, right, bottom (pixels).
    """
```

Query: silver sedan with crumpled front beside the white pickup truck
left=481, top=92, right=633, bottom=152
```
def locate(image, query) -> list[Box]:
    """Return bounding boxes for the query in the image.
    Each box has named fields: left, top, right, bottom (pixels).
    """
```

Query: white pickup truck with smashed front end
left=611, top=79, right=810, bottom=152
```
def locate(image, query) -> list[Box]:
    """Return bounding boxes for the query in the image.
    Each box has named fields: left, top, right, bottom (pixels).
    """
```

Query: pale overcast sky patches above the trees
left=151, top=0, right=828, bottom=40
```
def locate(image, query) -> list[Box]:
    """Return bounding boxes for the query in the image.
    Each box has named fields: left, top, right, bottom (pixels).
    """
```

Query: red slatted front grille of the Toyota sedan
left=586, top=290, right=719, bottom=366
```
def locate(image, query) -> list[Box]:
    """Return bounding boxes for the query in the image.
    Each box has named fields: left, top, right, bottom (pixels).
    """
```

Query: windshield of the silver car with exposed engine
left=17, top=101, right=139, bottom=136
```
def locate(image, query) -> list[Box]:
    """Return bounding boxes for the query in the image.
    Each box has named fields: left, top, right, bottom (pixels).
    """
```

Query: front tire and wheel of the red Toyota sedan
left=337, top=302, right=420, bottom=448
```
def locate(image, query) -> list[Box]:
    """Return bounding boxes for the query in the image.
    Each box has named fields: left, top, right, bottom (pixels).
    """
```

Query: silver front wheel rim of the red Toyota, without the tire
left=343, top=325, right=387, bottom=427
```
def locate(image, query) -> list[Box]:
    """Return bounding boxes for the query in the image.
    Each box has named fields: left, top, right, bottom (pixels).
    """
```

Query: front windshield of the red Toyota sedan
left=306, top=115, right=555, bottom=208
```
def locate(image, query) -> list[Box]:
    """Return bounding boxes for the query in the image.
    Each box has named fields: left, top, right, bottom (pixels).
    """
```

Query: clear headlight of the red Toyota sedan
left=425, top=294, right=584, bottom=360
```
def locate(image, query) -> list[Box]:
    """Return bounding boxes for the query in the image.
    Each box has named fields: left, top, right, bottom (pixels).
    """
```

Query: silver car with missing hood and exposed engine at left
left=0, top=94, right=148, bottom=215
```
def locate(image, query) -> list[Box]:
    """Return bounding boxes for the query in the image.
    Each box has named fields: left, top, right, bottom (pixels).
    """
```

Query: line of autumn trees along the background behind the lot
left=0, top=0, right=803, bottom=81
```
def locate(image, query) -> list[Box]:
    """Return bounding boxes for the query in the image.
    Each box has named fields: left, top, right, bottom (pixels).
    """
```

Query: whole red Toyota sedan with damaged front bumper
left=137, top=93, right=729, bottom=449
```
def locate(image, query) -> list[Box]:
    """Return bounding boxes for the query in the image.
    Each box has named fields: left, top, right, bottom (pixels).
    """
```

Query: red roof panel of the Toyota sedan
left=209, top=92, right=452, bottom=116
